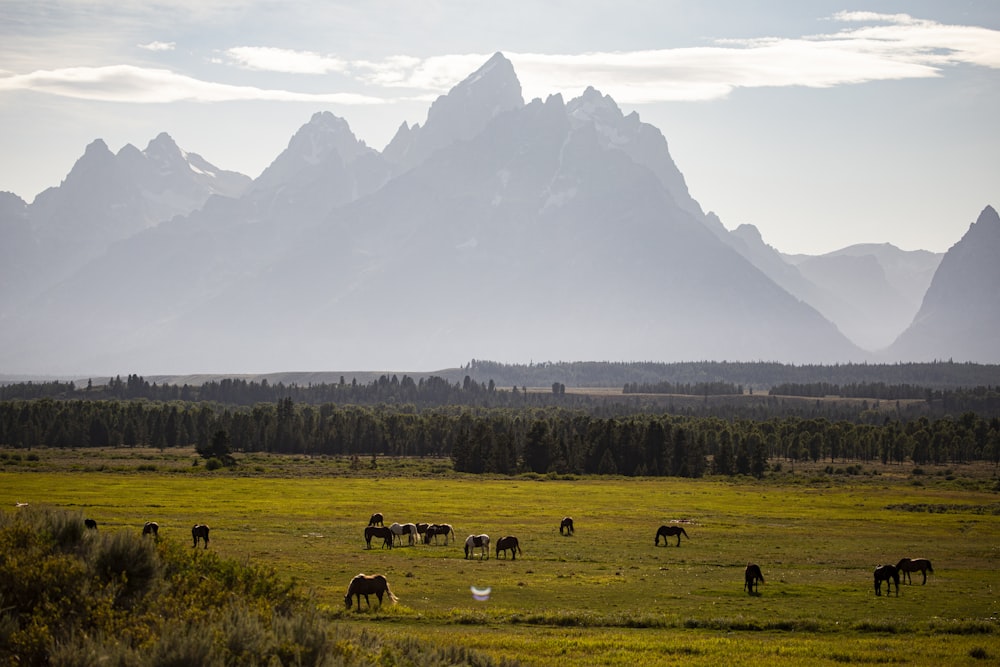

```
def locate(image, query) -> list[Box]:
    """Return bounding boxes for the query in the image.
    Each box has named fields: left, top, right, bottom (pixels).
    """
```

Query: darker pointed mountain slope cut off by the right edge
left=886, top=206, right=1000, bottom=363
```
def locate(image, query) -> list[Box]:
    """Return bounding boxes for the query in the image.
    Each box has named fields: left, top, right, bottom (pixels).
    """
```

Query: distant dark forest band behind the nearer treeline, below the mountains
left=0, top=364, right=1000, bottom=420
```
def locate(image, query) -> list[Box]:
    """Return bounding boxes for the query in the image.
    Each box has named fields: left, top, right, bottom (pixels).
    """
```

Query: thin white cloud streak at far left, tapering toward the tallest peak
left=0, top=65, right=385, bottom=105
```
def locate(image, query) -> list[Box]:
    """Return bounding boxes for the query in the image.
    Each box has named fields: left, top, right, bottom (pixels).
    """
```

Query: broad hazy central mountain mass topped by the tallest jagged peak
left=0, top=54, right=863, bottom=372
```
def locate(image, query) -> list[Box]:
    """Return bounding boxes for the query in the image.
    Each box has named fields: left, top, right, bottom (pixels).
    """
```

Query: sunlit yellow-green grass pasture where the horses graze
left=0, top=449, right=1000, bottom=665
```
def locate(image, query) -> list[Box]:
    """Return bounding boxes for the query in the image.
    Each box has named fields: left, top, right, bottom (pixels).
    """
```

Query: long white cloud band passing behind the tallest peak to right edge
left=352, top=12, right=1000, bottom=104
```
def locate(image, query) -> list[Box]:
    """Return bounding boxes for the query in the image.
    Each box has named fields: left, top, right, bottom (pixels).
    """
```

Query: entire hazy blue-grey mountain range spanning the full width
left=0, top=53, right=1000, bottom=374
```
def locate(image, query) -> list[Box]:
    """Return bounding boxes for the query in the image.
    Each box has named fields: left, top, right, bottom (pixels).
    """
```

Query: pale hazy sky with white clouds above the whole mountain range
left=0, top=0, right=1000, bottom=254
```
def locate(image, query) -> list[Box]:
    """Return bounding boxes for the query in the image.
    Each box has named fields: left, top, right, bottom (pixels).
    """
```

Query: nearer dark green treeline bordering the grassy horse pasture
left=0, top=398, right=1000, bottom=477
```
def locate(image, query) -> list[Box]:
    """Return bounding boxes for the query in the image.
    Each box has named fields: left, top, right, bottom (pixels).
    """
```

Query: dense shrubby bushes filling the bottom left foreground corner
left=0, top=507, right=516, bottom=667
